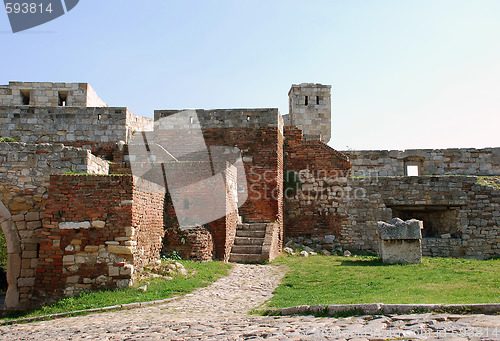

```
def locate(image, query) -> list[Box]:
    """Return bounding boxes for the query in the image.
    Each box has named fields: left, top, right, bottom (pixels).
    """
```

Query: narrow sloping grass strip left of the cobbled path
left=5, top=261, right=231, bottom=320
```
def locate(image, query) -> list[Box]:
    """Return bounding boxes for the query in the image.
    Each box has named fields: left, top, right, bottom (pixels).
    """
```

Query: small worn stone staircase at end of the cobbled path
left=229, top=223, right=267, bottom=263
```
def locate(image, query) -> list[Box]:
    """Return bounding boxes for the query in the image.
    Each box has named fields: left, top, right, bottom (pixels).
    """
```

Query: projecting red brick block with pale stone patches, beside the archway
left=33, top=175, right=164, bottom=303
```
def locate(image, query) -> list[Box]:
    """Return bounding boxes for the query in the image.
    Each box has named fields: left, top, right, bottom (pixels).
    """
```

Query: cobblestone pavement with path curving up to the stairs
left=0, top=265, right=500, bottom=341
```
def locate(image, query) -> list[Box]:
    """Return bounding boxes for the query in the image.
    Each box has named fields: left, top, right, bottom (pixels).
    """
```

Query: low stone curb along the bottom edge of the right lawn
left=265, top=303, right=500, bottom=317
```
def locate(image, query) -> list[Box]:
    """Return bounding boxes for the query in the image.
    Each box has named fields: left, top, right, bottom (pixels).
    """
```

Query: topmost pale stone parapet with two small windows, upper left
left=0, top=82, right=107, bottom=107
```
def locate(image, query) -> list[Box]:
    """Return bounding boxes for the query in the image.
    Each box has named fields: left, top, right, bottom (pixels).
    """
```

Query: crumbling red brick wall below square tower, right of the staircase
left=285, top=127, right=351, bottom=237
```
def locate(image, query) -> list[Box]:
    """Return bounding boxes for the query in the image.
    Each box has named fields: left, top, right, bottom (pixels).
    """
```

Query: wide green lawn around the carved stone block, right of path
left=268, top=255, right=500, bottom=308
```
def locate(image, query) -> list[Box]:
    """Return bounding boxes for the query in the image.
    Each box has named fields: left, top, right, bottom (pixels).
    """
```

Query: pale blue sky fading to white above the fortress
left=0, top=0, right=500, bottom=150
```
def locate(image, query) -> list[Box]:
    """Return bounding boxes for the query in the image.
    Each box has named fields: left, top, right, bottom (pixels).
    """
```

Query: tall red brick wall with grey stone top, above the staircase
left=155, top=109, right=283, bottom=226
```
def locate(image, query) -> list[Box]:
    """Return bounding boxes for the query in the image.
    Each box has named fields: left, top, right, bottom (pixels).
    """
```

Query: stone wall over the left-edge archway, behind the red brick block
left=0, top=143, right=109, bottom=308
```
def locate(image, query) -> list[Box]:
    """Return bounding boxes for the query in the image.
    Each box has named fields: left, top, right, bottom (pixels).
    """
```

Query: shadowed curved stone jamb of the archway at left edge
left=0, top=201, right=21, bottom=309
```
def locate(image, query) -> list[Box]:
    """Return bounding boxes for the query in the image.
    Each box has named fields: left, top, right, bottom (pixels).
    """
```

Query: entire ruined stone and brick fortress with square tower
left=0, top=82, right=500, bottom=309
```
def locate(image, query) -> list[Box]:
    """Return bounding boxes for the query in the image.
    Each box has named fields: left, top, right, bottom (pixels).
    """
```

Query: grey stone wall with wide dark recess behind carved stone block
left=337, top=176, right=500, bottom=259
